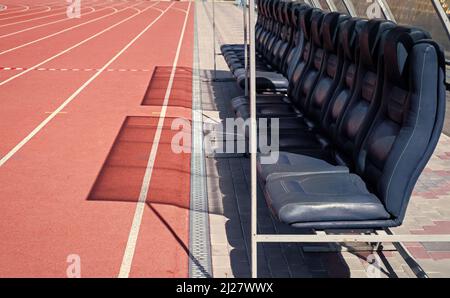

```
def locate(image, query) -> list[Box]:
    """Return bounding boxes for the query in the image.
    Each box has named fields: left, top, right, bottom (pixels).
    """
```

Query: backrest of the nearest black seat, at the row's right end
left=358, top=27, right=446, bottom=224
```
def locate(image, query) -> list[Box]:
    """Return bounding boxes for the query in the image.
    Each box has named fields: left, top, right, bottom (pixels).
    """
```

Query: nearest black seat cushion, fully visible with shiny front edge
left=265, top=173, right=391, bottom=225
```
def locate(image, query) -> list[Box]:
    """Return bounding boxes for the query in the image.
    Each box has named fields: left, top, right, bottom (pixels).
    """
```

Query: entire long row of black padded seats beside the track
left=222, top=0, right=445, bottom=229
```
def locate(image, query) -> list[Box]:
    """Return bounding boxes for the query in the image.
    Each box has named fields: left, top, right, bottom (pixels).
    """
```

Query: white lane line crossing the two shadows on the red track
left=119, top=1, right=192, bottom=278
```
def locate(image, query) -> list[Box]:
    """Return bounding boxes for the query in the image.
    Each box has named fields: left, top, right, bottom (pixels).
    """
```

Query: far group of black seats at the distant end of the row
left=221, top=1, right=303, bottom=92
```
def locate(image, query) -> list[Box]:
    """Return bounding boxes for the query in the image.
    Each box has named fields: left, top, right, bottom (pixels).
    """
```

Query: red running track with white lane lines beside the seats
left=0, top=0, right=194, bottom=277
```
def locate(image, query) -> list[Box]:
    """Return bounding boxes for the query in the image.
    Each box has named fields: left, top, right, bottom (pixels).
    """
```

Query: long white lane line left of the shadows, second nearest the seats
left=0, top=2, right=174, bottom=167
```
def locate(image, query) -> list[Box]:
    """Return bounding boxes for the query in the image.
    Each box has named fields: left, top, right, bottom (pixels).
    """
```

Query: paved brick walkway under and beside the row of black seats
left=196, top=2, right=450, bottom=277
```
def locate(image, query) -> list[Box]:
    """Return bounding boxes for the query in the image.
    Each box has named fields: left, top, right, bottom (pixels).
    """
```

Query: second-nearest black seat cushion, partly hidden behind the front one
left=257, top=152, right=349, bottom=185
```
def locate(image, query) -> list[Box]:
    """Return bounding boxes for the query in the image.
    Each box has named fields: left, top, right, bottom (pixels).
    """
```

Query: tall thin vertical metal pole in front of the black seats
left=248, top=0, right=258, bottom=278
